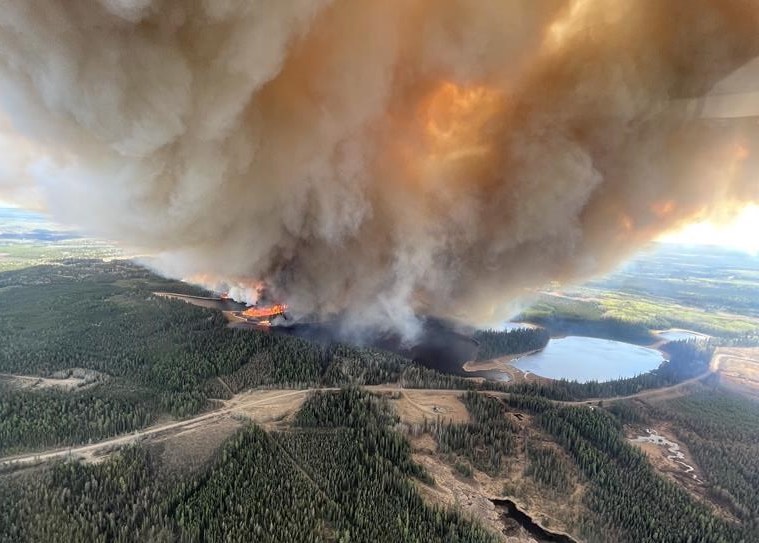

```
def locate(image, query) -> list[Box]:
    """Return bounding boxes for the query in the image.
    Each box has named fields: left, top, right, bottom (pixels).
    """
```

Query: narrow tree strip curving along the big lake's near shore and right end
left=498, top=341, right=714, bottom=401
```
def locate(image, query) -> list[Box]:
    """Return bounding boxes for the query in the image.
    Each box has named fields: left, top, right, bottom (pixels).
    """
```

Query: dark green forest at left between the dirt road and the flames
left=0, top=260, right=452, bottom=454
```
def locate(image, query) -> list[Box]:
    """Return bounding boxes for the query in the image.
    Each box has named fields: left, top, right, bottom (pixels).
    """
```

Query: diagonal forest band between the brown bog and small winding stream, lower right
left=506, top=396, right=756, bottom=543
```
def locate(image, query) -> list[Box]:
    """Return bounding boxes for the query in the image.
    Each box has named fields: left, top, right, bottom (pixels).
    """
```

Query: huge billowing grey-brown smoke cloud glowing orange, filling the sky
left=0, top=0, right=759, bottom=331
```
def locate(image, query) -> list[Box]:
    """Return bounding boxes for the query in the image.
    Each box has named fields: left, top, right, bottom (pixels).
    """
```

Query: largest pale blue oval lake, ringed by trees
left=514, top=336, right=664, bottom=383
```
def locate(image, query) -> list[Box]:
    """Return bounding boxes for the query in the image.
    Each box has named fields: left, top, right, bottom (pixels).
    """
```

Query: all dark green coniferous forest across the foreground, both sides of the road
left=0, top=261, right=759, bottom=543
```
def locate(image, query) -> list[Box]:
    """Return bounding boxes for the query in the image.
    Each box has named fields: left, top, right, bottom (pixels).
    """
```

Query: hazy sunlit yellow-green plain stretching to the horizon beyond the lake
left=522, top=245, right=759, bottom=337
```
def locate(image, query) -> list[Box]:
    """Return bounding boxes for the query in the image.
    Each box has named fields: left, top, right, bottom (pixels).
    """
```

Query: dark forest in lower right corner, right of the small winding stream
left=655, top=389, right=759, bottom=537
